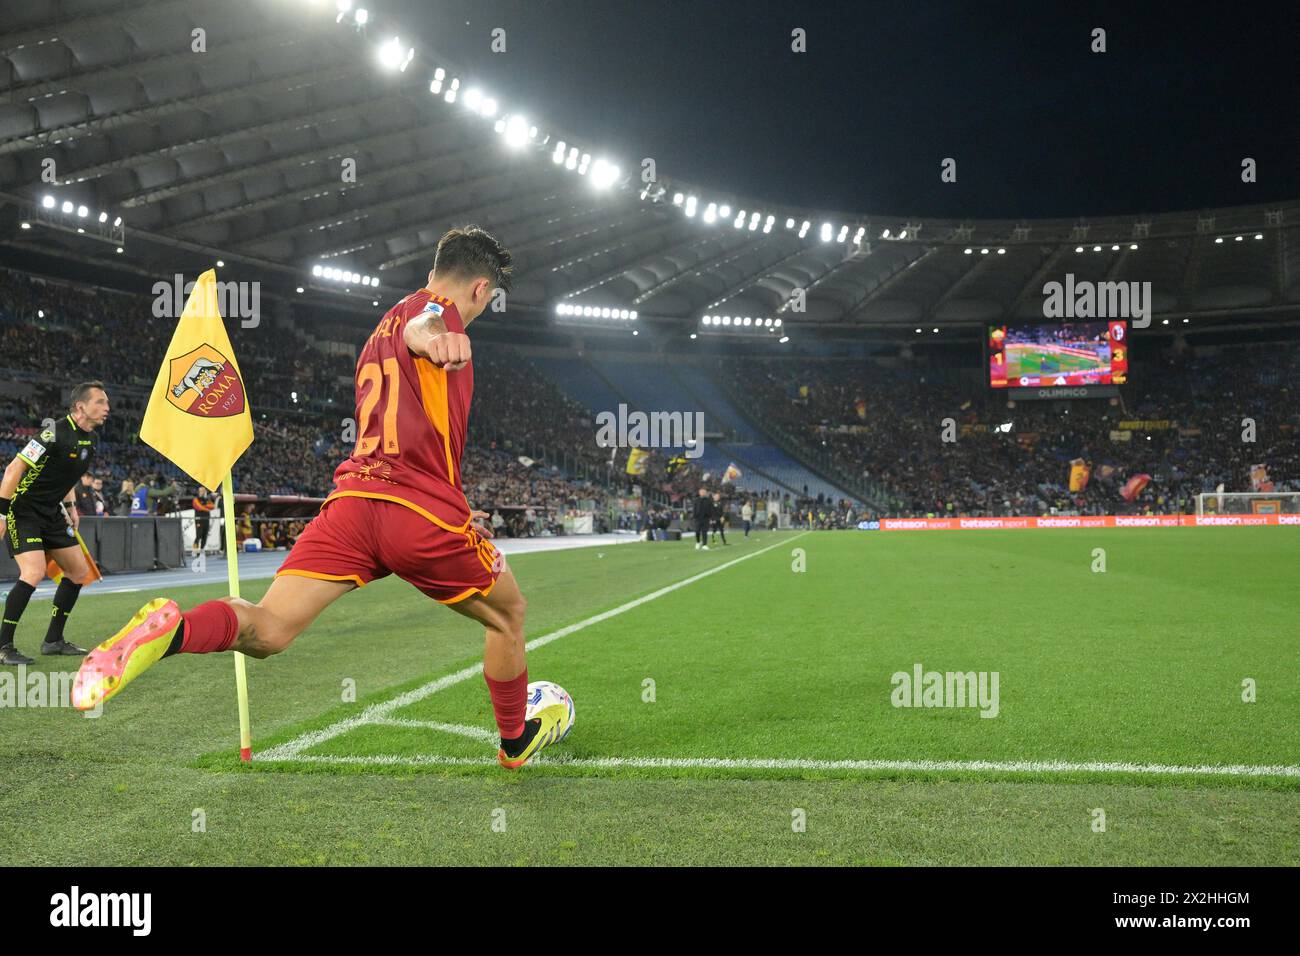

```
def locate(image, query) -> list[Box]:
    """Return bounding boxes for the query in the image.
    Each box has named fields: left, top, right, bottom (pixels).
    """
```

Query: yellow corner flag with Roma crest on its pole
left=140, top=269, right=252, bottom=761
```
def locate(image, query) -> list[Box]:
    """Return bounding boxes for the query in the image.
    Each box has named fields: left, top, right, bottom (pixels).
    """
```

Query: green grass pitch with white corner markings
left=0, top=528, right=1300, bottom=865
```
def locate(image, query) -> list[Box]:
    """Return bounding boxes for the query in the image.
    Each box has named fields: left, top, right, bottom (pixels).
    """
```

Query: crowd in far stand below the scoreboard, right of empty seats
left=727, top=346, right=1300, bottom=516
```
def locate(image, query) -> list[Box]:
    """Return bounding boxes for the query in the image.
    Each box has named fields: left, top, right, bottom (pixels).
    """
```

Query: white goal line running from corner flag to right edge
left=253, top=754, right=1300, bottom=778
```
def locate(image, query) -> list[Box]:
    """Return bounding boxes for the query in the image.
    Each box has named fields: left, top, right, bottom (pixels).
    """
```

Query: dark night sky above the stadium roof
left=387, top=0, right=1300, bottom=217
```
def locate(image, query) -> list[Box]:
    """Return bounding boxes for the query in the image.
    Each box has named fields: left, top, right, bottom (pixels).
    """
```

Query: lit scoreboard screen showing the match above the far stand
left=987, top=320, right=1128, bottom=389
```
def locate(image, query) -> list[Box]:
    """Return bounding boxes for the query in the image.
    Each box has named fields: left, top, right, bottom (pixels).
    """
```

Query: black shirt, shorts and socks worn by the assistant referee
left=0, top=415, right=99, bottom=665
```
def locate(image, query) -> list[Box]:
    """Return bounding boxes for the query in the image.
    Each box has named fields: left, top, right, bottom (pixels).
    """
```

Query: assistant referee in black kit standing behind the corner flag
left=0, top=381, right=108, bottom=665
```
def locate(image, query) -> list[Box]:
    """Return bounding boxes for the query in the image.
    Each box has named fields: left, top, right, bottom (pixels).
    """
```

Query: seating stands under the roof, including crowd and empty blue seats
left=0, top=267, right=1300, bottom=524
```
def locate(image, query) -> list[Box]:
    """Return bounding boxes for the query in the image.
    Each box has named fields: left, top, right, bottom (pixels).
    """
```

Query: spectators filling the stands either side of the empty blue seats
left=0, top=269, right=1300, bottom=530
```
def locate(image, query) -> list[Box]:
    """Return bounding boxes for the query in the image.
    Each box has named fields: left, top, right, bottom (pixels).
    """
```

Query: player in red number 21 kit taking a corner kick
left=73, top=228, right=567, bottom=769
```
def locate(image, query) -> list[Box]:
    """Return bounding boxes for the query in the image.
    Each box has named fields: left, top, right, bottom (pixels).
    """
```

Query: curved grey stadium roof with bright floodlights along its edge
left=0, top=0, right=1300, bottom=334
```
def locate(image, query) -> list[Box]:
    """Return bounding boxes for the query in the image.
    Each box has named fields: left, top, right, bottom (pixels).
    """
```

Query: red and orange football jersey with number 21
left=325, top=289, right=475, bottom=532
